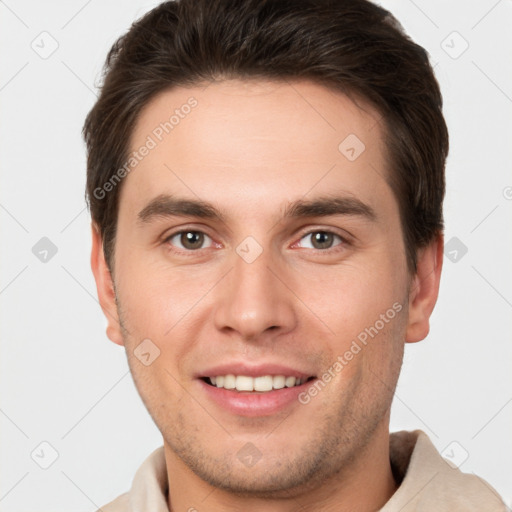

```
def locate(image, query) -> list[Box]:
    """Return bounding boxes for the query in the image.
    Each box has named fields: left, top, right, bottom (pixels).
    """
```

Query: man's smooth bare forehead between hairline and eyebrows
left=121, top=80, right=389, bottom=219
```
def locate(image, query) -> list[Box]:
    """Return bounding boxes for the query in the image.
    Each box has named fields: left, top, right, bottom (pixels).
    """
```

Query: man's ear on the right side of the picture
left=405, top=233, right=444, bottom=343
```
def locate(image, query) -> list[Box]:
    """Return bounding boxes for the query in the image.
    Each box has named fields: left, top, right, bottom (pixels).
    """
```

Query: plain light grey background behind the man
left=0, top=0, right=512, bottom=512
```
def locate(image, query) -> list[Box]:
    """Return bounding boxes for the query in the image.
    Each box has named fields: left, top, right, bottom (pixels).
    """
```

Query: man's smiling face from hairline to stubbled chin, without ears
left=99, top=81, right=410, bottom=495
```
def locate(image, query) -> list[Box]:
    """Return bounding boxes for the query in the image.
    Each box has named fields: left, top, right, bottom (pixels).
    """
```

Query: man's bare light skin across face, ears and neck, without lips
left=92, top=80, right=443, bottom=512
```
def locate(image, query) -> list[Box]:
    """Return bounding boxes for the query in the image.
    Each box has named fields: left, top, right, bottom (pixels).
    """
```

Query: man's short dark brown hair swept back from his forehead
left=83, top=0, right=448, bottom=272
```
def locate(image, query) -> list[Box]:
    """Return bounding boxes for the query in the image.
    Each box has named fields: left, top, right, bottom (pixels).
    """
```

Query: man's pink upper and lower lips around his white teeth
left=195, top=362, right=317, bottom=417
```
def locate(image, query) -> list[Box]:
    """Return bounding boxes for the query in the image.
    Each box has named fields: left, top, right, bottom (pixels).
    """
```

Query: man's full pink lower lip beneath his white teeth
left=198, top=379, right=316, bottom=417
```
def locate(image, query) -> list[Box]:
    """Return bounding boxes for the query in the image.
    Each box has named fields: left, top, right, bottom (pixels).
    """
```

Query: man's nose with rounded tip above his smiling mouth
left=214, top=245, right=297, bottom=341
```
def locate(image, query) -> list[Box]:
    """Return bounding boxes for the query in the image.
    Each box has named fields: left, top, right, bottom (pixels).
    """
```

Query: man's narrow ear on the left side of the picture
left=91, top=223, right=124, bottom=345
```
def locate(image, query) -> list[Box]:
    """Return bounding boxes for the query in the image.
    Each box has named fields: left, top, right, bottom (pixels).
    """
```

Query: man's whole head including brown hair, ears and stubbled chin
left=84, top=0, right=448, bottom=504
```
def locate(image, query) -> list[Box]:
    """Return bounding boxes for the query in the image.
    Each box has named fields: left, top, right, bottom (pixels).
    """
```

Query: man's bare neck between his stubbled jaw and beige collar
left=164, top=424, right=397, bottom=512
